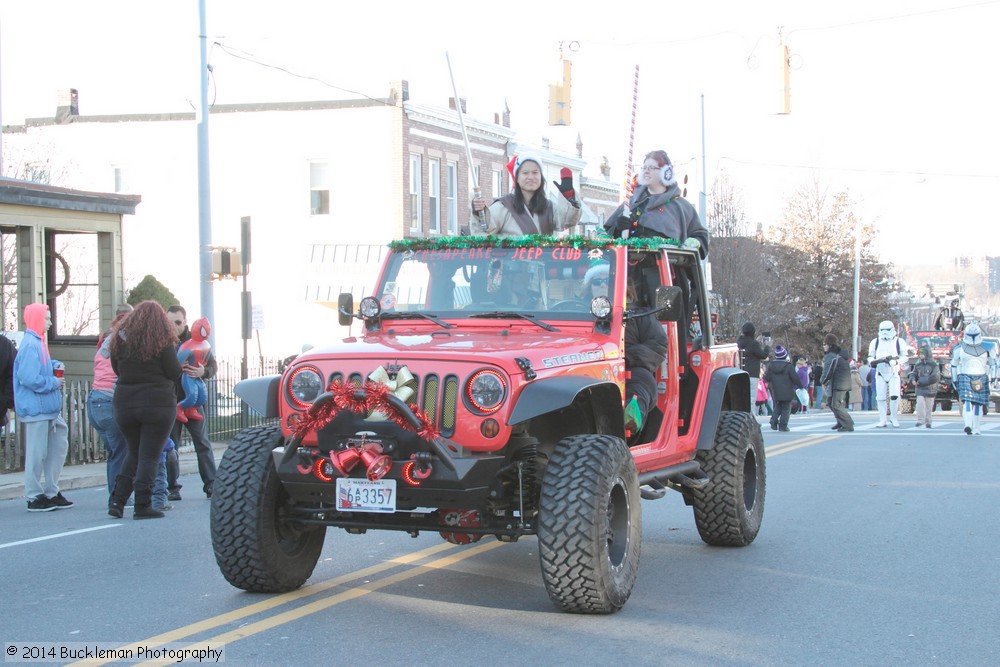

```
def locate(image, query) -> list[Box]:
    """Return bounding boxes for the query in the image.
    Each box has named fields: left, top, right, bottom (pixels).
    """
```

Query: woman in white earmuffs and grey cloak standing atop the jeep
left=604, top=151, right=708, bottom=259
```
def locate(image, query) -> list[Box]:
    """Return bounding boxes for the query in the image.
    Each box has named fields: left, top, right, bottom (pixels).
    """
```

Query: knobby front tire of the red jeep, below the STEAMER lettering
left=538, top=434, right=642, bottom=614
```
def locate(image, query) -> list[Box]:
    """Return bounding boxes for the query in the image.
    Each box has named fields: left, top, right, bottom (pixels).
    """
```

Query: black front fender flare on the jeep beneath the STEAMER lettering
left=507, top=375, right=620, bottom=426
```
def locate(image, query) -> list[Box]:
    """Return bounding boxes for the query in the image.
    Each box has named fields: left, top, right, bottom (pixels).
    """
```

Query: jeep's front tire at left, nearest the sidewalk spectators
left=211, top=426, right=326, bottom=593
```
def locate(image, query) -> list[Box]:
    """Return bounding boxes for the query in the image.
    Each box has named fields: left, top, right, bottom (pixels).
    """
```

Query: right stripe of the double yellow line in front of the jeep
left=131, top=540, right=505, bottom=667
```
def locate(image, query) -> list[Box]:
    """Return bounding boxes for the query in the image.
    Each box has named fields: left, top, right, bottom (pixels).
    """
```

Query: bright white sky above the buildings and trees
left=0, top=0, right=1000, bottom=264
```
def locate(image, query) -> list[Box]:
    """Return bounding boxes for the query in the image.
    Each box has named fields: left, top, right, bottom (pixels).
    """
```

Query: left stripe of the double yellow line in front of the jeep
left=71, top=542, right=468, bottom=667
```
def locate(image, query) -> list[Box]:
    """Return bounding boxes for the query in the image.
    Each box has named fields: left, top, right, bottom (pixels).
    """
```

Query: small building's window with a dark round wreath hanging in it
left=45, top=230, right=101, bottom=337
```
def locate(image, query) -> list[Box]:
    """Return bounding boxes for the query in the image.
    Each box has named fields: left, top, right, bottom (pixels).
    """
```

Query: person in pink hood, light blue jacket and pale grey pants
left=13, top=303, right=73, bottom=512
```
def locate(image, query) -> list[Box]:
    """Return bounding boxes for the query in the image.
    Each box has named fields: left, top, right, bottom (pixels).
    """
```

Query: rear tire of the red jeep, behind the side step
left=690, top=411, right=766, bottom=547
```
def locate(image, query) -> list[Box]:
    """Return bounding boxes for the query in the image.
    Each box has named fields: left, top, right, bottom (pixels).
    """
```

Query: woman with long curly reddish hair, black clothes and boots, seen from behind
left=108, top=301, right=181, bottom=519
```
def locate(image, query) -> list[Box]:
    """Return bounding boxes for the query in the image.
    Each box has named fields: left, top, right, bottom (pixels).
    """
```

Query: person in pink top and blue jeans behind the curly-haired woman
left=87, top=303, right=132, bottom=499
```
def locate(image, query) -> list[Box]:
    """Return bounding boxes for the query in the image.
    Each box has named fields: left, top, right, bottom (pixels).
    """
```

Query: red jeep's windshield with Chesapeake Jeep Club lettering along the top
left=375, top=245, right=615, bottom=320
